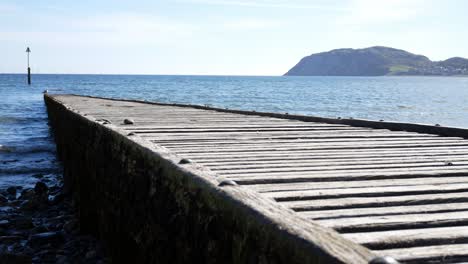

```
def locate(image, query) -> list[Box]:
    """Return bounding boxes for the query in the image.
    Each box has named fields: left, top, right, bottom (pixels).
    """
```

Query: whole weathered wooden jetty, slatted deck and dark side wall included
left=45, top=95, right=468, bottom=263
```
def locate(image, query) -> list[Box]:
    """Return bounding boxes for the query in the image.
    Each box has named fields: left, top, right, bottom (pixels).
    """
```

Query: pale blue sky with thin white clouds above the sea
left=0, top=0, right=468, bottom=75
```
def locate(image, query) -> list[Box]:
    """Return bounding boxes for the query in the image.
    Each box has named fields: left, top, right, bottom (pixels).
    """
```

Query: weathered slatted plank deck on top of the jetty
left=47, top=96, right=468, bottom=263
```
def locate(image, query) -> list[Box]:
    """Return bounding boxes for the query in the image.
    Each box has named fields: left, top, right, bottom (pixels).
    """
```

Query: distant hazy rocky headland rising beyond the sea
left=285, top=46, right=468, bottom=76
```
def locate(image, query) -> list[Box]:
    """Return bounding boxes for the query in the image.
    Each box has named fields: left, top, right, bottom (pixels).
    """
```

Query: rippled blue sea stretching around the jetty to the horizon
left=0, top=74, right=468, bottom=188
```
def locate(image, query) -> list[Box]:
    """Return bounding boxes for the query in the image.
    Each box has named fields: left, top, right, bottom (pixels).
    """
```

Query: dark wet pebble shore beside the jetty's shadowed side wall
left=0, top=174, right=111, bottom=264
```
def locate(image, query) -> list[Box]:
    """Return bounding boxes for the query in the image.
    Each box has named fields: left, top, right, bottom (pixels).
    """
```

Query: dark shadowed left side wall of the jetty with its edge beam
left=45, top=95, right=371, bottom=264
